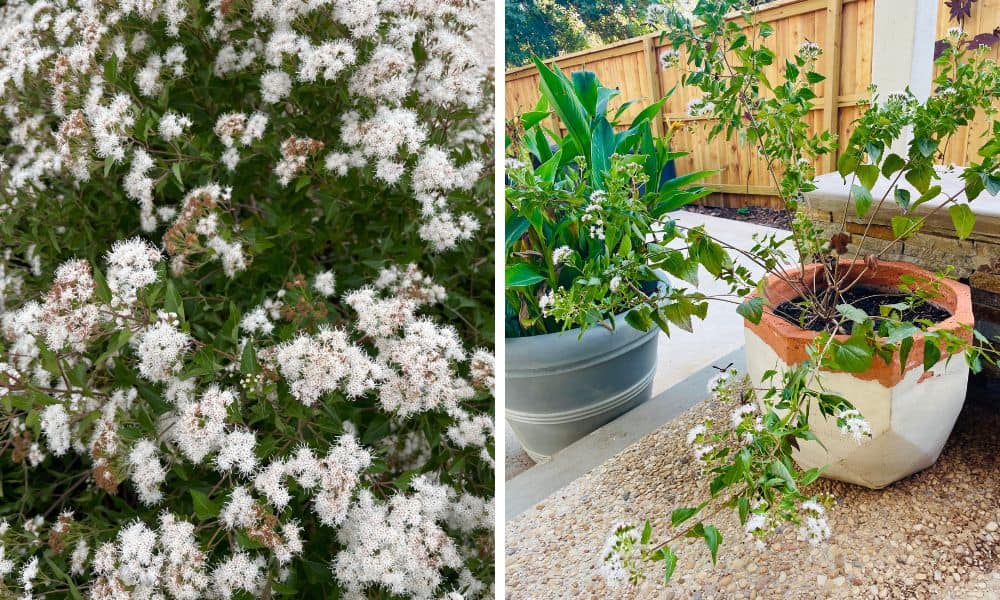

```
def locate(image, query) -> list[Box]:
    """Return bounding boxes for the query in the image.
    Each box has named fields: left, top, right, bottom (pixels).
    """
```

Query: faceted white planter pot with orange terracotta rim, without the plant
left=744, top=261, right=973, bottom=489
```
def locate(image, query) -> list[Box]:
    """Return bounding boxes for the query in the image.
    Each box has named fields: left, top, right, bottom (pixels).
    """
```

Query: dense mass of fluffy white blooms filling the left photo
left=0, top=0, right=494, bottom=599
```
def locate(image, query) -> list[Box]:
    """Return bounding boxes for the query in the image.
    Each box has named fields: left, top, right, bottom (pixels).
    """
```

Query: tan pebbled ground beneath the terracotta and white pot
left=506, top=401, right=1000, bottom=600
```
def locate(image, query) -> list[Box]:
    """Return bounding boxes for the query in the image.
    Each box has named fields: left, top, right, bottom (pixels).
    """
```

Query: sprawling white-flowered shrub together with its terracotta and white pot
left=601, top=0, right=1000, bottom=583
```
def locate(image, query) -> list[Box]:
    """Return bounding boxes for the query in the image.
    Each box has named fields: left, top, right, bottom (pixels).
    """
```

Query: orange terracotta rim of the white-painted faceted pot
left=743, top=260, right=975, bottom=387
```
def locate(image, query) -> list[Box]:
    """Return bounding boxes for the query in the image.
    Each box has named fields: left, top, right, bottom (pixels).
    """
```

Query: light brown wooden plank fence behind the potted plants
left=506, top=0, right=1000, bottom=207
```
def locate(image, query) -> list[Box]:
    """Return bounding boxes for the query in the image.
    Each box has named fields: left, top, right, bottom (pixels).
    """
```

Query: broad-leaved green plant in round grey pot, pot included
left=505, top=61, right=729, bottom=460
